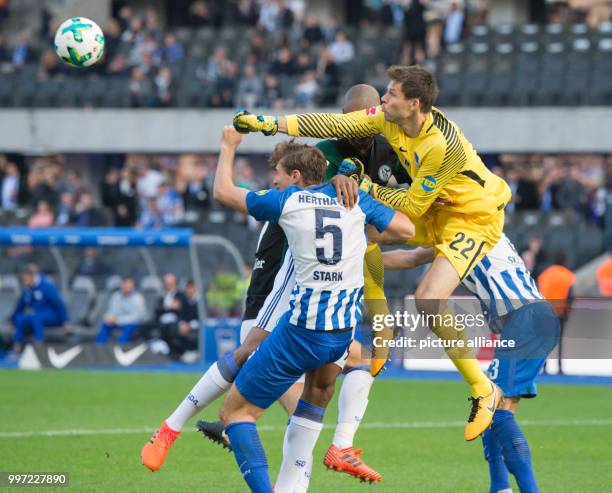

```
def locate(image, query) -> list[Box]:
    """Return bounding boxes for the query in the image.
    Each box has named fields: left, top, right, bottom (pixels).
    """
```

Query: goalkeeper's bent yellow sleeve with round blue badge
left=373, top=135, right=466, bottom=218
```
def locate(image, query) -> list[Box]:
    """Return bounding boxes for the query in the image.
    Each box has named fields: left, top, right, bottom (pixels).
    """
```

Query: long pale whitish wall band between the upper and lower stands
left=0, top=108, right=612, bottom=153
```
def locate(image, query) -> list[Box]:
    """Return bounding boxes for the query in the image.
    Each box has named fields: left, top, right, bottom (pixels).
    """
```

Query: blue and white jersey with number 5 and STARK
left=246, top=184, right=394, bottom=330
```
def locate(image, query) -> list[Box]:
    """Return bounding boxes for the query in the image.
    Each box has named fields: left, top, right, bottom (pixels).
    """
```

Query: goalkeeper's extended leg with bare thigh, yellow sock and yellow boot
left=415, top=255, right=503, bottom=441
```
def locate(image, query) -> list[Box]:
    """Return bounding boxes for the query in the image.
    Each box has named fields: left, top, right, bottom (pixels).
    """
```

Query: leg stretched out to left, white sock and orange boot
left=140, top=320, right=269, bottom=471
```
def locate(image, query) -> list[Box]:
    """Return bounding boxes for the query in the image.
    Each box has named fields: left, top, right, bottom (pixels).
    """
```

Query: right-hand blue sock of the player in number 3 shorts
left=491, top=409, right=538, bottom=493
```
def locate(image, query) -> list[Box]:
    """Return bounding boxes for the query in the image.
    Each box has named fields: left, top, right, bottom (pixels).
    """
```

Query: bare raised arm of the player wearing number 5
left=213, top=125, right=248, bottom=213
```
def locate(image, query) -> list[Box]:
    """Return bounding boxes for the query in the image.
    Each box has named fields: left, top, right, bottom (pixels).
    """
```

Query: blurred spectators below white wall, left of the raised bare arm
left=0, top=154, right=265, bottom=228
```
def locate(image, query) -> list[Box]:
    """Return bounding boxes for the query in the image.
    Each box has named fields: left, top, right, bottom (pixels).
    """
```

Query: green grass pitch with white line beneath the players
left=0, top=371, right=612, bottom=493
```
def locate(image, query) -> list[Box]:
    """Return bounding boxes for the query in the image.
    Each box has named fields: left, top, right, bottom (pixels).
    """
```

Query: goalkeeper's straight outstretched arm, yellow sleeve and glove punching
left=233, top=108, right=385, bottom=139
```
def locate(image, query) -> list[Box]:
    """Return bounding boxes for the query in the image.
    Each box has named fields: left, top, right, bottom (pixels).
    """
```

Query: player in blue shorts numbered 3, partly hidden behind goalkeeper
left=383, top=235, right=559, bottom=493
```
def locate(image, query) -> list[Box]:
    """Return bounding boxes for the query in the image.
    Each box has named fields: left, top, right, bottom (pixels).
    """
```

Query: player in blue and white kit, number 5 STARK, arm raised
left=214, top=126, right=414, bottom=493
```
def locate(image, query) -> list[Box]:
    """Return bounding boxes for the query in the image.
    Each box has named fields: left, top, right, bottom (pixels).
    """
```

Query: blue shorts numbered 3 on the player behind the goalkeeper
left=488, top=302, right=560, bottom=398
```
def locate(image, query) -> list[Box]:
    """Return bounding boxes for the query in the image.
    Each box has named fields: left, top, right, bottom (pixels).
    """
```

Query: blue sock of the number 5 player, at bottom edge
left=225, top=422, right=273, bottom=493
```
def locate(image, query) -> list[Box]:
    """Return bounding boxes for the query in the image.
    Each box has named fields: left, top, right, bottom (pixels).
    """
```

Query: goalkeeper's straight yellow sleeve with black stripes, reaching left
left=286, top=106, right=385, bottom=139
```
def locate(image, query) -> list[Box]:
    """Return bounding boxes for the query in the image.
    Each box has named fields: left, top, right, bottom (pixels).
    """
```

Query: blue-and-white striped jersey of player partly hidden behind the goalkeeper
left=463, top=234, right=544, bottom=322
